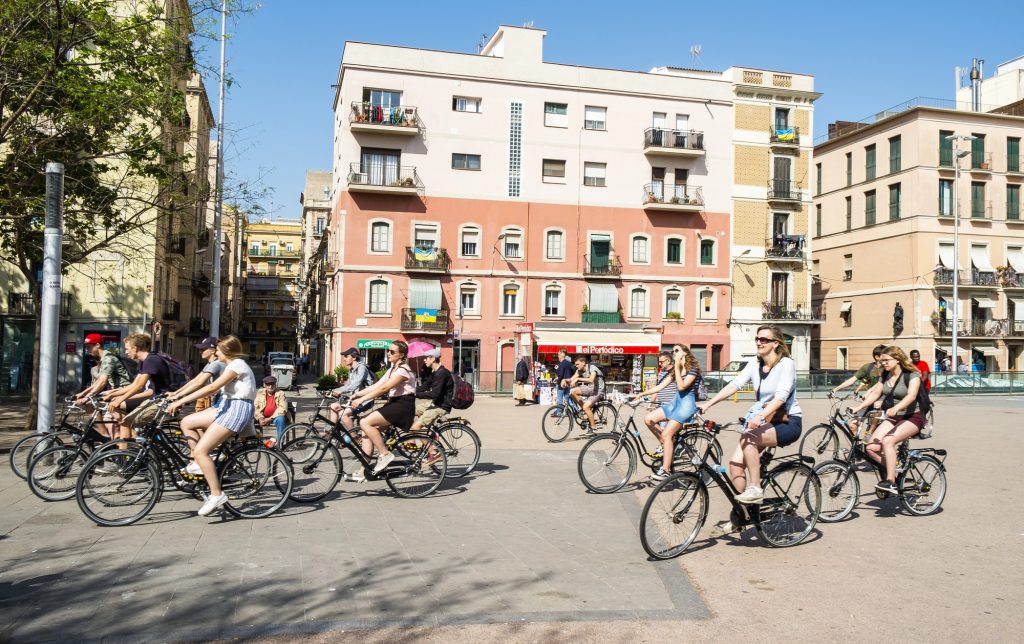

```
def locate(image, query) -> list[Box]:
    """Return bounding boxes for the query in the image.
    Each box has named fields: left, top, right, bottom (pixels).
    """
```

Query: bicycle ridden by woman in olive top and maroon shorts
left=814, top=411, right=946, bottom=523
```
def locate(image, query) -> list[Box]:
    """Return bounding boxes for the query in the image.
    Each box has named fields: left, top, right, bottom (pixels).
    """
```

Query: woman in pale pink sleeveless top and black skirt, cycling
left=348, top=340, right=416, bottom=474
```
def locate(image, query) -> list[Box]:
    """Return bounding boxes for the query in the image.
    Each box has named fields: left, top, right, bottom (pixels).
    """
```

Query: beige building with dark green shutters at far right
left=812, top=101, right=1024, bottom=371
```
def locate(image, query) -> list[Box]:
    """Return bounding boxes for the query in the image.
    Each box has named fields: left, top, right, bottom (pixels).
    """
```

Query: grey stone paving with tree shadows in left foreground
left=0, top=449, right=709, bottom=641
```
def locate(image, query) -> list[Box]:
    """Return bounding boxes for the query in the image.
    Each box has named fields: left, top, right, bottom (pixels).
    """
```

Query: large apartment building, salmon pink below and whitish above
left=321, top=27, right=749, bottom=387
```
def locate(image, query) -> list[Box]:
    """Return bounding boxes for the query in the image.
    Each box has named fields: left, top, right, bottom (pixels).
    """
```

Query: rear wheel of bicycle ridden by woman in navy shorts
left=755, top=463, right=821, bottom=548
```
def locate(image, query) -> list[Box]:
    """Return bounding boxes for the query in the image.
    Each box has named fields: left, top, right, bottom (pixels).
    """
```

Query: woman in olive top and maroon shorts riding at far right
left=853, top=345, right=925, bottom=492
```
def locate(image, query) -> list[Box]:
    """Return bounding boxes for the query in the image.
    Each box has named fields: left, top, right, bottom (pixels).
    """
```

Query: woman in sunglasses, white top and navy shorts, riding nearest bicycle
left=697, top=325, right=803, bottom=511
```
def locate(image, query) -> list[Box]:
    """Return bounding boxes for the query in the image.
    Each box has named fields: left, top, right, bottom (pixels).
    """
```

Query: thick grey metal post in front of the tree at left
left=36, top=163, right=63, bottom=434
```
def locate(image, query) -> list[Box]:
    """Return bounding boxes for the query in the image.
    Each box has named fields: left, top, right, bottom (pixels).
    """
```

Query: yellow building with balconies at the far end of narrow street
left=239, top=220, right=302, bottom=357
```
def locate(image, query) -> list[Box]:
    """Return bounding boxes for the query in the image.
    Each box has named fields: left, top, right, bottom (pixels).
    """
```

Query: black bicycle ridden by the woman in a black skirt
left=281, top=399, right=447, bottom=503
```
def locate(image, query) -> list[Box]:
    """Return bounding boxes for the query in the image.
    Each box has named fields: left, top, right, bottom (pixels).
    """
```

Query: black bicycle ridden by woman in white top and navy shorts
left=640, top=420, right=821, bottom=559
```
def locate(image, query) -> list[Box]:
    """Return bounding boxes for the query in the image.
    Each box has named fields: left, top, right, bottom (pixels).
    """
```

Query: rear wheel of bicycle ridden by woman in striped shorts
left=217, top=442, right=293, bottom=519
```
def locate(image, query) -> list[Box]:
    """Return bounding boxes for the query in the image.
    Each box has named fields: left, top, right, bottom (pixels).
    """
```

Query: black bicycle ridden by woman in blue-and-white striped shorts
left=75, top=398, right=293, bottom=526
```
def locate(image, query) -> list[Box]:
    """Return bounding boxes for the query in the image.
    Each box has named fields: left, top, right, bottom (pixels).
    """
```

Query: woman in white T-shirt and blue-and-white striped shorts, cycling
left=168, top=336, right=257, bottom=516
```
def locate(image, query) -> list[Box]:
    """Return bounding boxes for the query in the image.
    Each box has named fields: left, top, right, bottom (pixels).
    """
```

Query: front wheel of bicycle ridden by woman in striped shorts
left=75, top=449, right=162, bottom=526
